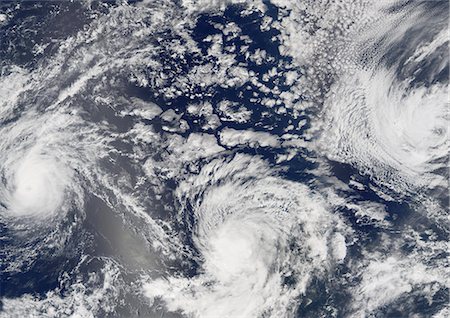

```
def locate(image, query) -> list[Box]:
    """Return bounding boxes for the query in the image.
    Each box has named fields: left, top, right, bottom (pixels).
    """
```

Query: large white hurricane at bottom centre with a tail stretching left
left=144, top=156, right=346, bottom=317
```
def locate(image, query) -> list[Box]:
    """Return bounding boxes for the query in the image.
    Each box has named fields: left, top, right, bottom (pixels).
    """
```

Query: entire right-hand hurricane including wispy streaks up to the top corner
left=318, top=4, right=449, bottom=199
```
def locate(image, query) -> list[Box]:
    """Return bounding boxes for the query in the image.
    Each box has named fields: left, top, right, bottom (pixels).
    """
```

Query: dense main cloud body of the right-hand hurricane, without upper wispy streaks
left=322, top=38, right=449, bottom=196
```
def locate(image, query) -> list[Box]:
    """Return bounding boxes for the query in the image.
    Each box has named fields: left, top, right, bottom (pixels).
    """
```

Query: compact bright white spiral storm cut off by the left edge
left=0, top=112, right=86, bottom=219
